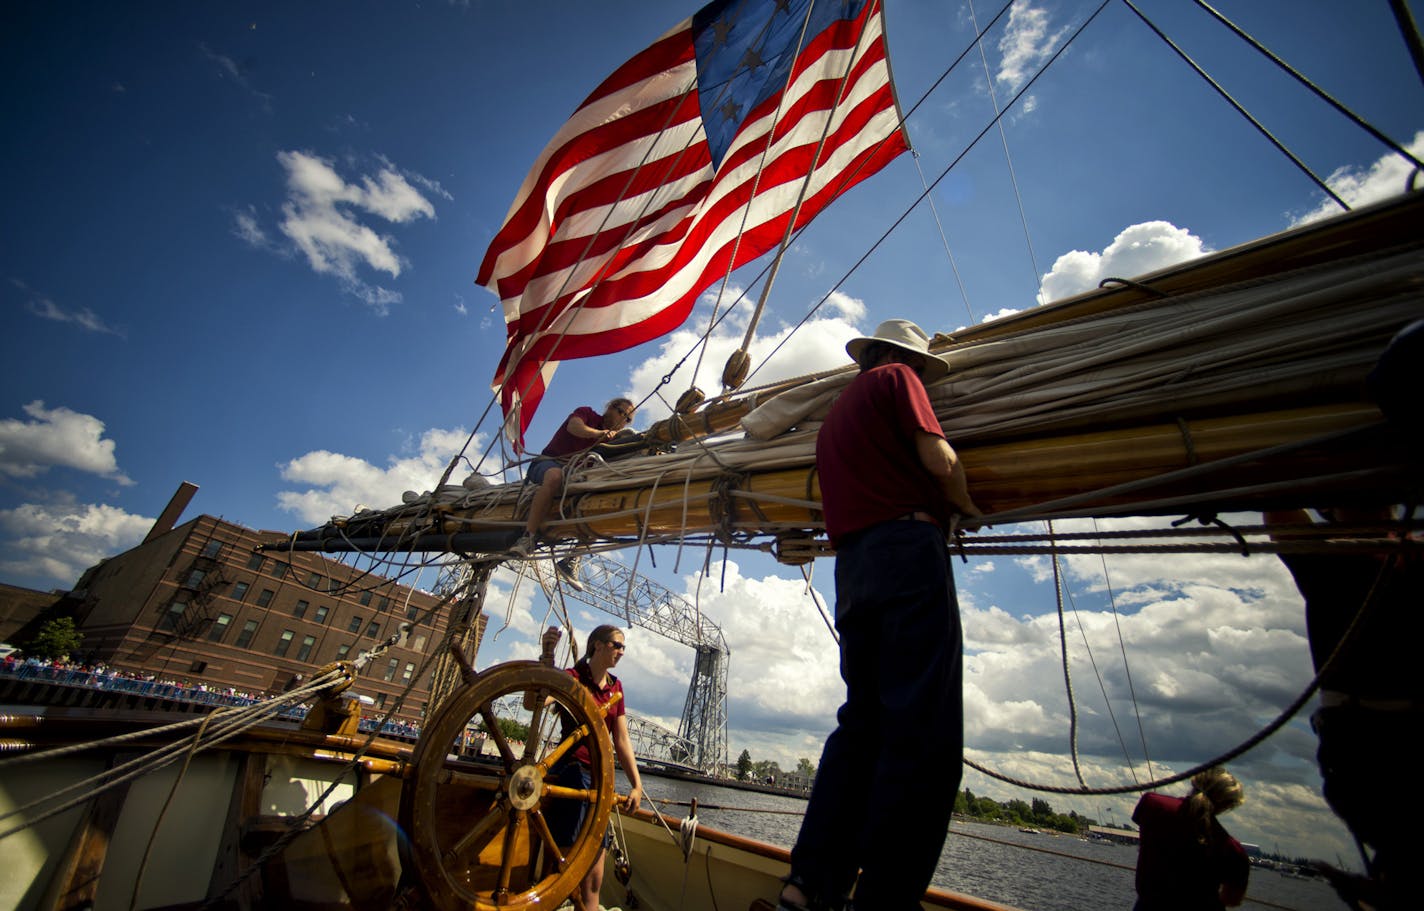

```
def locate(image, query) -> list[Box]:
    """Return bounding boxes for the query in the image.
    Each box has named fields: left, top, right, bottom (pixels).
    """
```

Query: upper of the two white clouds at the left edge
left=0, top=400, right=132, bottom=487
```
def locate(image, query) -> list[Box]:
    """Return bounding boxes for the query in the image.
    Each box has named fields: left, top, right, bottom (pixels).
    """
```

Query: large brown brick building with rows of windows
left=68, top=515, right=484, bottom=723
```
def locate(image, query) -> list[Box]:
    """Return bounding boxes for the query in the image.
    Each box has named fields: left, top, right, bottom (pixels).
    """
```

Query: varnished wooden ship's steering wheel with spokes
left=400, top=660, right=614, bottom=911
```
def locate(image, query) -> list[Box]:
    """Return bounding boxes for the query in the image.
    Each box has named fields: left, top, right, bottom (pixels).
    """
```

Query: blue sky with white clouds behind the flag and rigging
left=0, top=0, right=1424, bottom=857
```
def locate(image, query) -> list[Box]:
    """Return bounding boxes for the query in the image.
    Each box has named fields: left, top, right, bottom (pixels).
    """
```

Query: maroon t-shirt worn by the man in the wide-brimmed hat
left=816, top=363, right=954, bottom=545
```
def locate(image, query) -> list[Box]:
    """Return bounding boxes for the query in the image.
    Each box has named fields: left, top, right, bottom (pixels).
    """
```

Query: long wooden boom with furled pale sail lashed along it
left=272, top=194, right=1424, bottom=552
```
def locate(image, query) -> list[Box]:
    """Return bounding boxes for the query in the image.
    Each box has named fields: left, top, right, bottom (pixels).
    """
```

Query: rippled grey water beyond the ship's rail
left=618, top=773, right=1344, bottom=911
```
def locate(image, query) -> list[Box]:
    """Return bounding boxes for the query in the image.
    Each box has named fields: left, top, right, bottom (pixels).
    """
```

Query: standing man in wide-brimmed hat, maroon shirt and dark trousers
left=780, top=320, right=980, bottom=911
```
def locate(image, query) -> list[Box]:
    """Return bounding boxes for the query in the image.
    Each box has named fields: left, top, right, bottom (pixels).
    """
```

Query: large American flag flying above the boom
left=478, top=0, right=907, bottom=450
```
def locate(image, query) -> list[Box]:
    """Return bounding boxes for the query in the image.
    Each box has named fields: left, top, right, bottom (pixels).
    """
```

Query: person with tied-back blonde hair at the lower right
left=1132, top=766, right=1250, bottom=911
